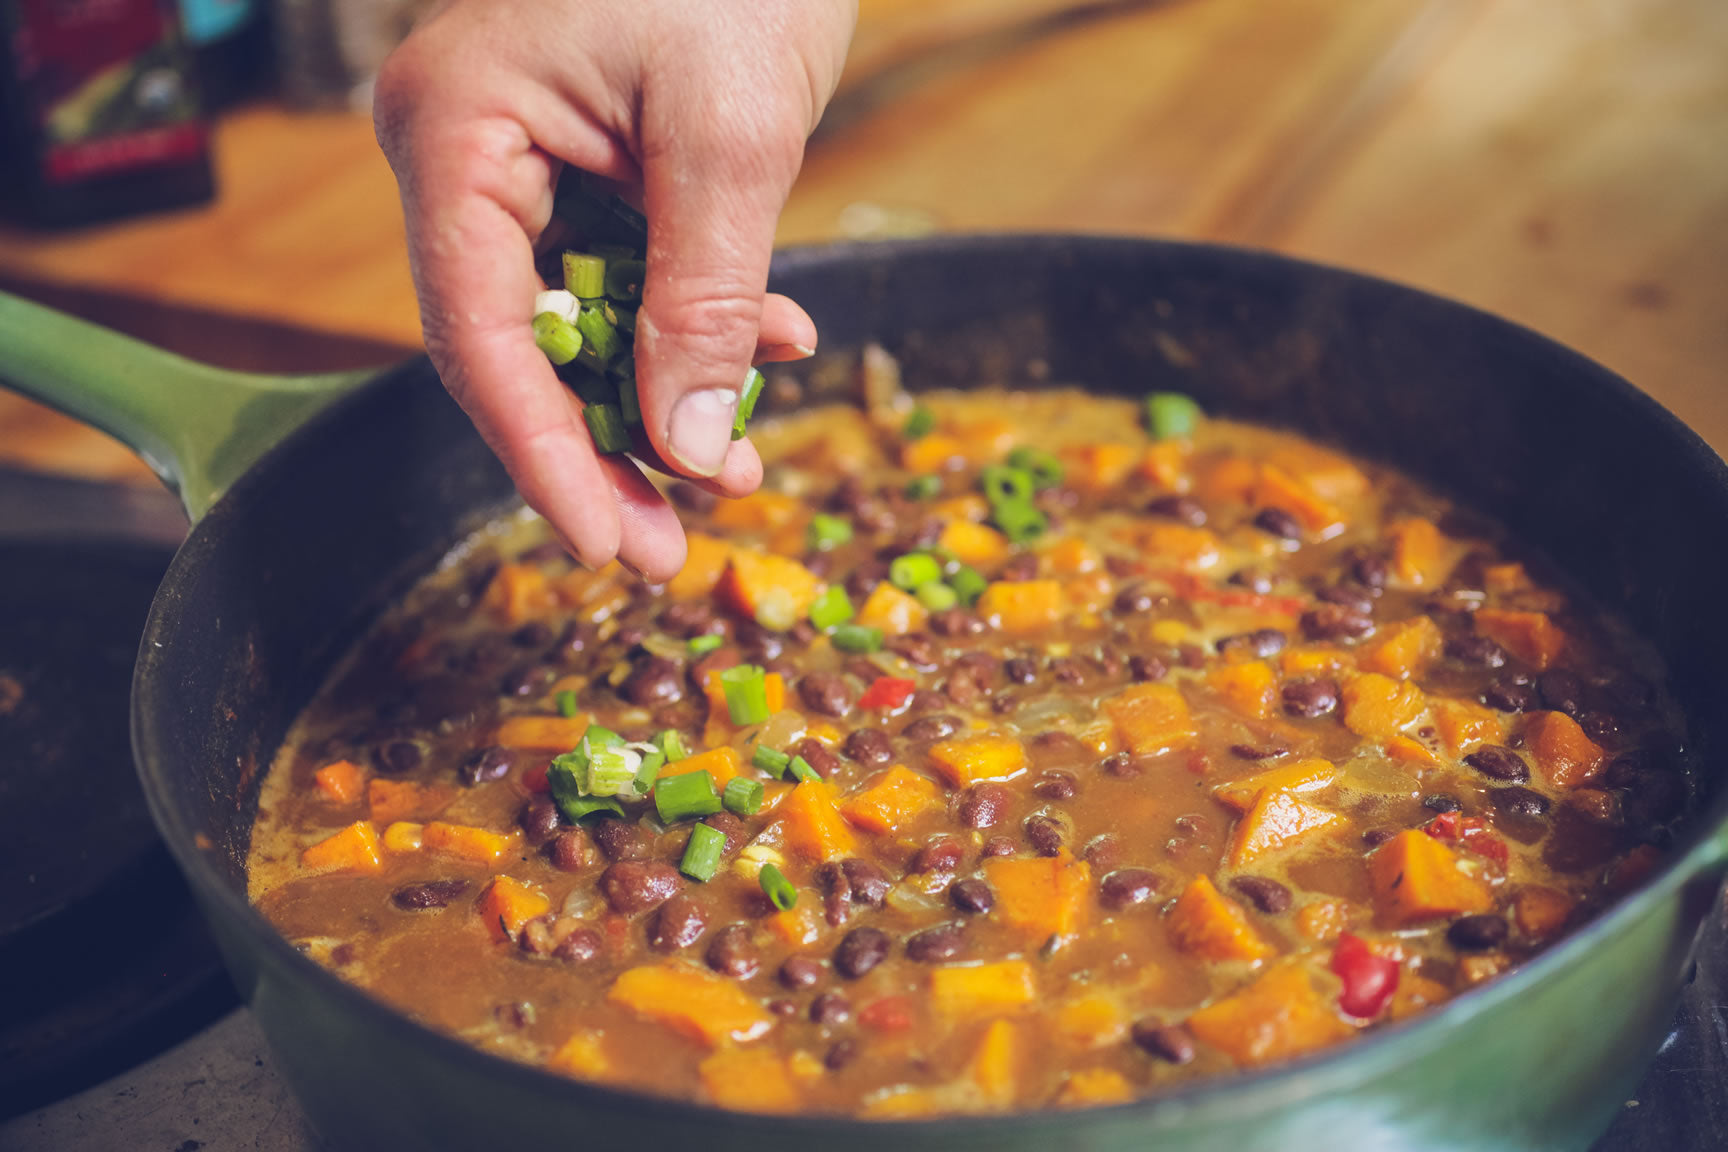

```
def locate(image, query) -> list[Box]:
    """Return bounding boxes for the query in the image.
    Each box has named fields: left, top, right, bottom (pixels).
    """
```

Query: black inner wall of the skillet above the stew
left=135, top=229, right=1728, bottom=1022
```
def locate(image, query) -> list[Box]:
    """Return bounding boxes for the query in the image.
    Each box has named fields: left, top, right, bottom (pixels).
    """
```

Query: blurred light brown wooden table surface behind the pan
left=0, top=0, right=1728, bottom=477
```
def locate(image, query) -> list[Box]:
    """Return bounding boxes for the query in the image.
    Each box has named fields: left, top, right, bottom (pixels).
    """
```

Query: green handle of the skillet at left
left=0, top=292, right=377, bottom=520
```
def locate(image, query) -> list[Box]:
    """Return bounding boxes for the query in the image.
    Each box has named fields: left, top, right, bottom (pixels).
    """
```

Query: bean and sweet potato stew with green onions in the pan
left=251, top=378, right=1687, bottom=1117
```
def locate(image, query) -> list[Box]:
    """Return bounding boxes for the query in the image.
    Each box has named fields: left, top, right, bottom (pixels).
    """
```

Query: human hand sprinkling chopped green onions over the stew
left=375, top=0, right=857, bottom=580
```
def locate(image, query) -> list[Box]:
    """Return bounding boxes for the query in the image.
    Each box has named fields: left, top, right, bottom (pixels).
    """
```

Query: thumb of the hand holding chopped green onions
left=636, top=79, right=807, bottom=477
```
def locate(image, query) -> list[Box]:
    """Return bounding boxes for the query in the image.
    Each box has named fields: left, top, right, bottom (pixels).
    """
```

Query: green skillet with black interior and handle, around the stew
left=0, top=237, right=1728, bottom=1152
